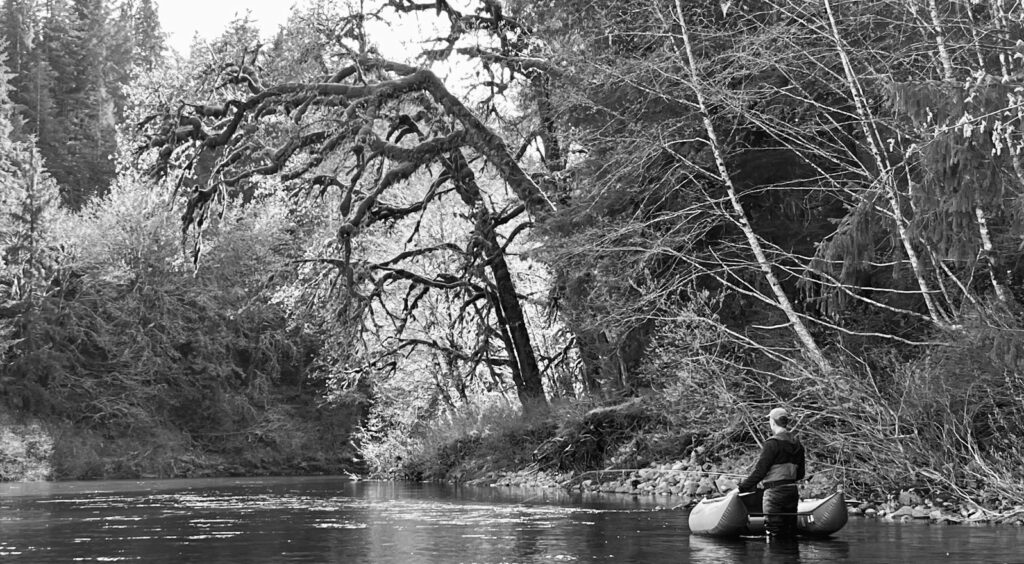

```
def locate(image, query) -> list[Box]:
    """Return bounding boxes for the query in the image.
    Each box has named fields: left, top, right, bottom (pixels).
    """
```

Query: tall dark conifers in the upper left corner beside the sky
left=0, top=0, right=164, bottom=208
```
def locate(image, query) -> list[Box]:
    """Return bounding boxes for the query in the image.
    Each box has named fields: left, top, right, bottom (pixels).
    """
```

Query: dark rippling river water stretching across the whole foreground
left=0, top=477, right=1024, bottom=564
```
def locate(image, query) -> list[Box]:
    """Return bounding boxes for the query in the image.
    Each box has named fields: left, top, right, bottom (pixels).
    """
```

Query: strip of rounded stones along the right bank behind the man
left=468, top=459, right=1024, bottom=526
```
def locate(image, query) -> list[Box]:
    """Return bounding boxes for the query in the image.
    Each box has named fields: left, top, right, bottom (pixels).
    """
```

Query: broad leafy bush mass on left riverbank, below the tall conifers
left=0, top=177, right=357, bottom=478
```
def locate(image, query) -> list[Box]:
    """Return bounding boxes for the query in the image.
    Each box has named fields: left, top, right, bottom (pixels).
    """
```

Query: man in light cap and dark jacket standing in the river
left=739, top=407, right=804, bottom=540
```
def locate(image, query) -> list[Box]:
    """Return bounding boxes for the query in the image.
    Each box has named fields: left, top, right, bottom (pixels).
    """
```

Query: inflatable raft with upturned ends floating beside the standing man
left=689, top=490, right=848, bottom=536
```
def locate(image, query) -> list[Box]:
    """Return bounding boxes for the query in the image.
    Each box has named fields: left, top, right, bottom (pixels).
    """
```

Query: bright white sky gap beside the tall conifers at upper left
left=157, top=0, right=298, bottom=55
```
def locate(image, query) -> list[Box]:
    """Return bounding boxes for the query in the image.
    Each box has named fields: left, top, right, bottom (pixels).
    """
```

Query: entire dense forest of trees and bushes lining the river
left=6, top=0, right=1024, bottom=509
